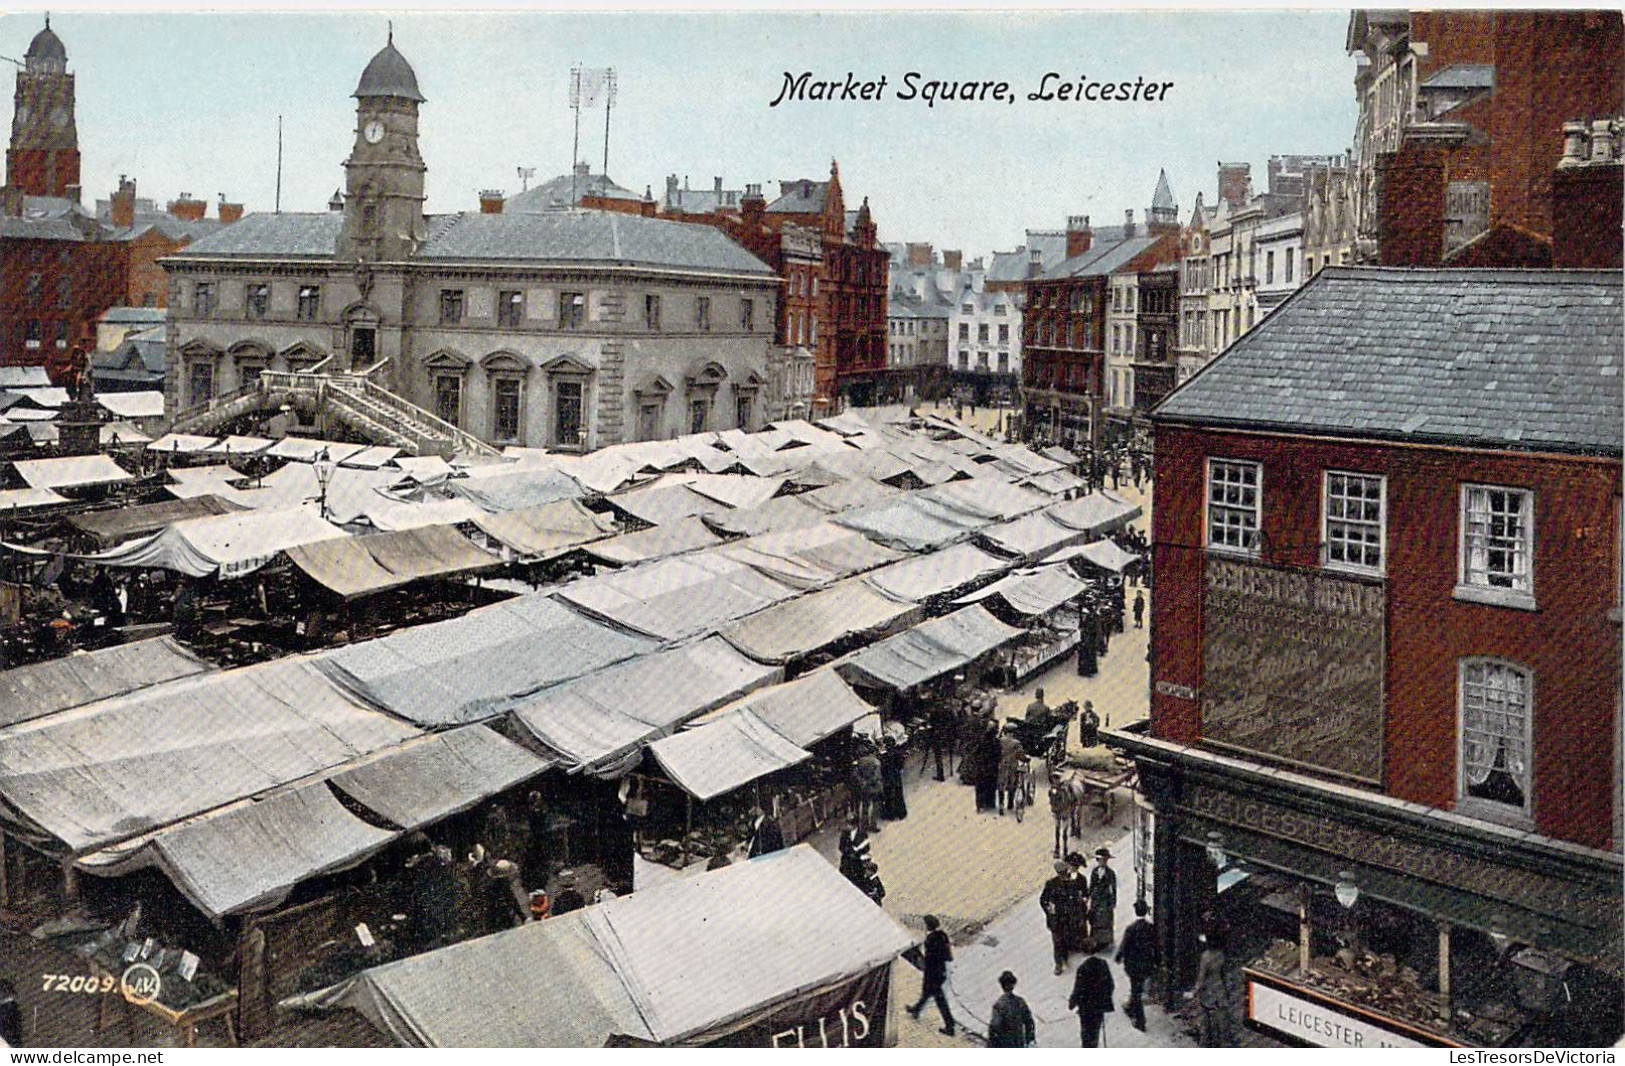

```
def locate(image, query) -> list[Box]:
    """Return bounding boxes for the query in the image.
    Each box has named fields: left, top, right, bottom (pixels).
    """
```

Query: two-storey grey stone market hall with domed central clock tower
left=166, top=41, right=780, bottom=450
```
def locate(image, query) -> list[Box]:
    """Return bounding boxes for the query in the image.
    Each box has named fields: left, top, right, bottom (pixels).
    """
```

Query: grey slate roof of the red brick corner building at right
left=1154, top=267, right=1625, bottom=455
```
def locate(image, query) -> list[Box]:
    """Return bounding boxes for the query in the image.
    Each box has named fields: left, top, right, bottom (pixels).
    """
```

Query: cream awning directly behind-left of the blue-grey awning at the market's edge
left=720, top=579, right=920, bottom=663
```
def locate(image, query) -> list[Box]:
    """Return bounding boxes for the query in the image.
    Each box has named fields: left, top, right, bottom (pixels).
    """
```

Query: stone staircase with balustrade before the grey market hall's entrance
left=171, top=362, right=501, bottom=457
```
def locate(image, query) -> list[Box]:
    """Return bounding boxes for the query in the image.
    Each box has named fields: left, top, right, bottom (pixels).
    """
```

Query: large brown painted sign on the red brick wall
left=1203, top=557, right=1388, bottom=783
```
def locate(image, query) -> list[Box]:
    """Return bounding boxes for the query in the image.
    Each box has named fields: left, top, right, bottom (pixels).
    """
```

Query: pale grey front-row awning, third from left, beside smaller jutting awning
left=514, top=637, right=783, bottom=777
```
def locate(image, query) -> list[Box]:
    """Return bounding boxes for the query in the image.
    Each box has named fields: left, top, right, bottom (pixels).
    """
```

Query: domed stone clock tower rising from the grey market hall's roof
left=338, top=33, right=427, bottom=263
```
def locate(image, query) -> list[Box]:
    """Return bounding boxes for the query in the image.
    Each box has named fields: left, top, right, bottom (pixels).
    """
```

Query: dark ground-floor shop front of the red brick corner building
left=1107, top=730, right=1625, bottom=1048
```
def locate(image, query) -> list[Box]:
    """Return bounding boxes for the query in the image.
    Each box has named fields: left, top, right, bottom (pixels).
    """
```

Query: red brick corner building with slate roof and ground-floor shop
left=1110, top=267, right=1625, bottom=1047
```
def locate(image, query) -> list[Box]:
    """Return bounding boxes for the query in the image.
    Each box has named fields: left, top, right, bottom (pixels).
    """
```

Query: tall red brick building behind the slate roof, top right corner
left=1349, top=10, right=1625, bottom=267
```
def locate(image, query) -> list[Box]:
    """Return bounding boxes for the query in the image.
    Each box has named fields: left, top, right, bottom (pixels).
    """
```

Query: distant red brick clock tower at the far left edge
left=5, top=16, right=80, bottom=200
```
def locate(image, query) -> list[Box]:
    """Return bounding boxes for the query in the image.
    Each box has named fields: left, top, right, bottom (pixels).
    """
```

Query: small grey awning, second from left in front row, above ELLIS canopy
left=330, top=725, right=553, bottom=830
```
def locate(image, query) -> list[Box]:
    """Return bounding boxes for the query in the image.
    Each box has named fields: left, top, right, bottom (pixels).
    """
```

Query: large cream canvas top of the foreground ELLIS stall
left=330, top=845, right=915, bottom=1048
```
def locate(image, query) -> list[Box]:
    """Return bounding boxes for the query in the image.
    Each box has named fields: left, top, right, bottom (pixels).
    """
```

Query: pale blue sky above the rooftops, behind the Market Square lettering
left=0, top=10, right=1355, bottom=258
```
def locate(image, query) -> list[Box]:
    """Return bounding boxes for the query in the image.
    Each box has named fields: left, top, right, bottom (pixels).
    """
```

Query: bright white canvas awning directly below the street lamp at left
left=81, top=507, right=348, bottom=577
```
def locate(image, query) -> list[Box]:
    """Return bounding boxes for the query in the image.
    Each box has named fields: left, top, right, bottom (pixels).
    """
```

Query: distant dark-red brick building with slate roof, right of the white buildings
left=1022, top=191, right=1181, bottom=447
